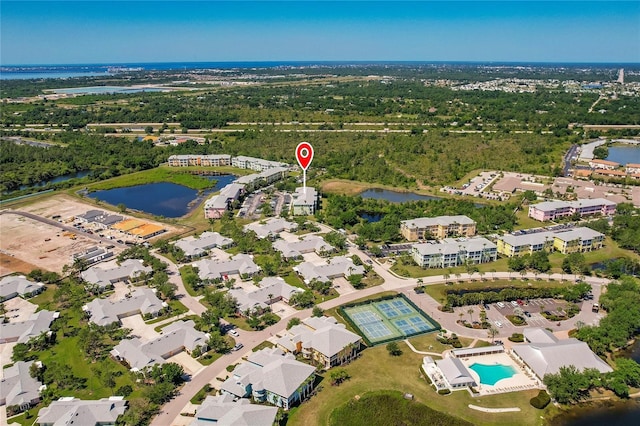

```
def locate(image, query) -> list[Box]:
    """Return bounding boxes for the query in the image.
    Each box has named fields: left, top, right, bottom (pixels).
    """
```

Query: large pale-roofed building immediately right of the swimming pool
left=512, top=328, right=613, bottom=380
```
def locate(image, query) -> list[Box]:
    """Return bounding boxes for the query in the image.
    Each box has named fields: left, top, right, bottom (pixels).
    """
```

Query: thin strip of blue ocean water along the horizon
left=0, top=61, right=640, bottom=80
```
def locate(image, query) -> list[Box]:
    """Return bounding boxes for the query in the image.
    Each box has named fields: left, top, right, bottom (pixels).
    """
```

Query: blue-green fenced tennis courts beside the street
left=342, top=295, right=440, bottom=345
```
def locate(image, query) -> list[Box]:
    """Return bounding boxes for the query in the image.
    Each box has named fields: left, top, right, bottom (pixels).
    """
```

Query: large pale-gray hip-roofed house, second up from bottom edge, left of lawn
left=220, top=348, right=315, bottom=410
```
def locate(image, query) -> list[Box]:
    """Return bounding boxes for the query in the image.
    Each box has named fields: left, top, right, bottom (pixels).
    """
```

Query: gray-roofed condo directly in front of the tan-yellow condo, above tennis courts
left=411, top=237, right=498, bottom=268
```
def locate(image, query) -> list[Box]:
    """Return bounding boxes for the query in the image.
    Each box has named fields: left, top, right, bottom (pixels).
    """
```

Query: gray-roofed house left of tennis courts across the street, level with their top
left=229, top=277, right=304, bottom=313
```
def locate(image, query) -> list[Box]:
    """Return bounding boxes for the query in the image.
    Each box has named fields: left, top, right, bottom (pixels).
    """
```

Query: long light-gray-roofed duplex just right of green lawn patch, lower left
left=111, top=320, right=209, bottom=371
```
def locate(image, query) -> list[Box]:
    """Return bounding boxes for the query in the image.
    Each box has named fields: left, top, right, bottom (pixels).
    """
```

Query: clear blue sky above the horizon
left=0, top=0, right=640, bottom=65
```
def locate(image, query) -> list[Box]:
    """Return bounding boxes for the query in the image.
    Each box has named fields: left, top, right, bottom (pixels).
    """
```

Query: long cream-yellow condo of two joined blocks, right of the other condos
left=497, top=227, right=604, bottom=257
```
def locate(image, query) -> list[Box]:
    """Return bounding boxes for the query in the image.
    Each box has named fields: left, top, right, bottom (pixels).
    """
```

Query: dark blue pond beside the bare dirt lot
left=89, top=175, right=236, bottom=217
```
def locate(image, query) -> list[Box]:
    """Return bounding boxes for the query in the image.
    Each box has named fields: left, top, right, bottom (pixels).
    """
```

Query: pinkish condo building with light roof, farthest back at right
left=529, top=198, right=617, bottom=222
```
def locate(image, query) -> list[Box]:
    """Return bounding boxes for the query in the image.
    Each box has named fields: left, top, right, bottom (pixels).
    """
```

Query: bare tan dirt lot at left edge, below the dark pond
left=0, top=194, right=185, bottom=276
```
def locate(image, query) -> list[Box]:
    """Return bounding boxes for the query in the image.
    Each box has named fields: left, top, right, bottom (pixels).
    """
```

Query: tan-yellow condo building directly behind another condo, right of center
left=400, top=215, right=476, bottom=241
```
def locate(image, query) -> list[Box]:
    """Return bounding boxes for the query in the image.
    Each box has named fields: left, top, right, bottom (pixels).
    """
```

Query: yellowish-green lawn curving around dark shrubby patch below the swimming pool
left=288, top=345, right=555, bottom=426
